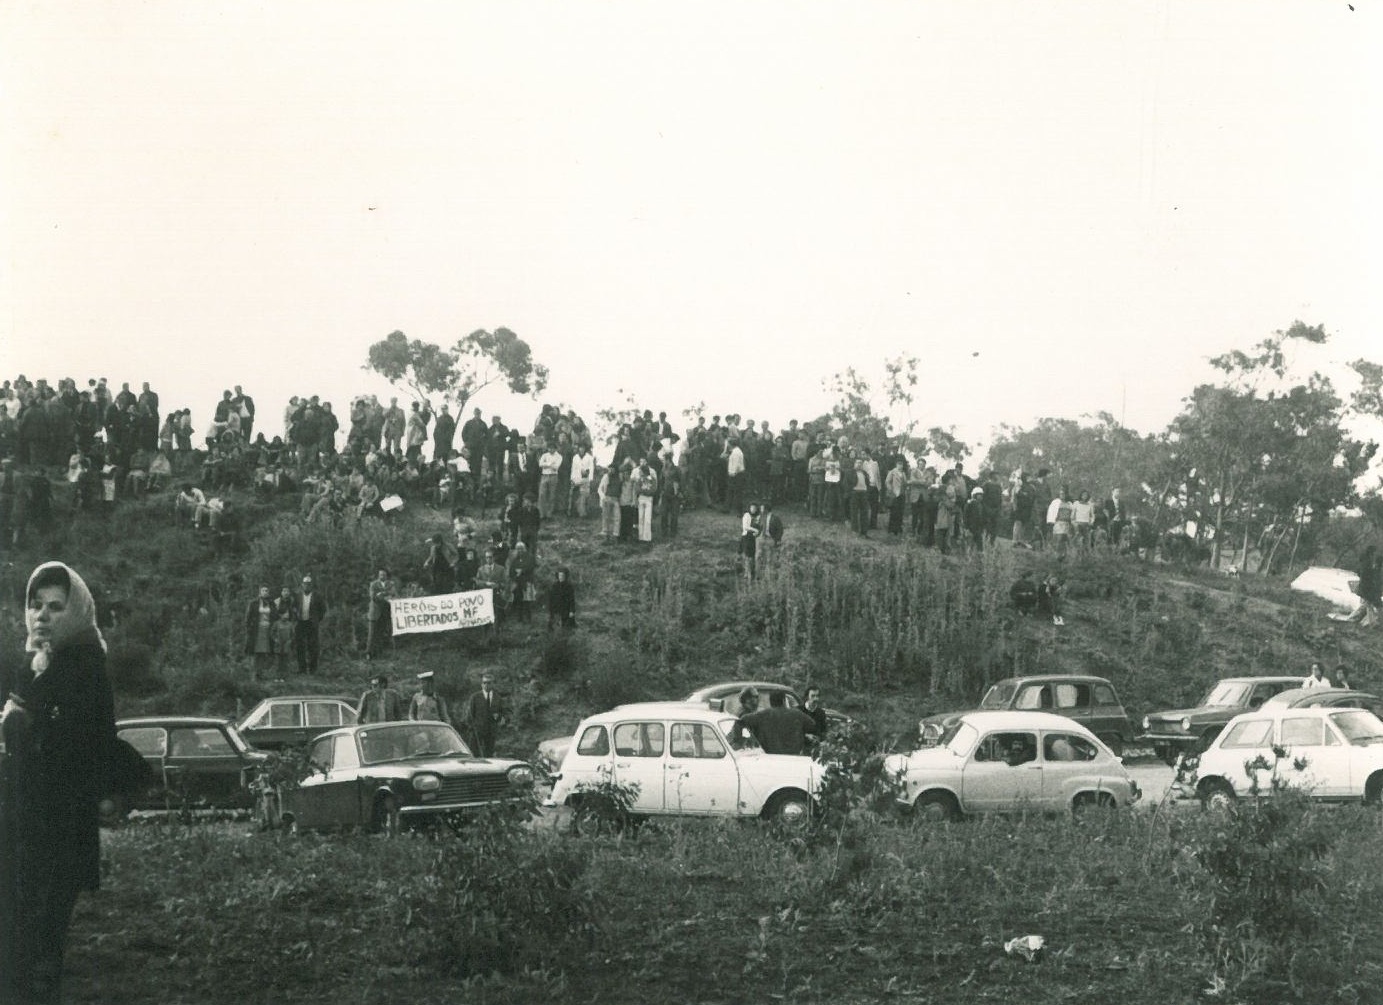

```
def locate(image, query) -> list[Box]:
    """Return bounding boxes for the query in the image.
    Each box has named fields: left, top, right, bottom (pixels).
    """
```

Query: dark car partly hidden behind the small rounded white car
left=918, top=673, right=1134, bottom=756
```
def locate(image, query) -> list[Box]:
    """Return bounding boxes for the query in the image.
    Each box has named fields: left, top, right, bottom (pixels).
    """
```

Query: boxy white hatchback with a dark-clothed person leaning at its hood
left=548, top=702, right=822, bottom=825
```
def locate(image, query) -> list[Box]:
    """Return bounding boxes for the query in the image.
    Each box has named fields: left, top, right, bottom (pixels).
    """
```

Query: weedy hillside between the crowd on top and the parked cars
left=0, top=483, right=1383, bottom=755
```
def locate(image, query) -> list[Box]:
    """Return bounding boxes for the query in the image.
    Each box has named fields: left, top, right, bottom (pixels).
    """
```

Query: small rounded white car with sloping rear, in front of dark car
left=884, top=712, right=1142, bottom=820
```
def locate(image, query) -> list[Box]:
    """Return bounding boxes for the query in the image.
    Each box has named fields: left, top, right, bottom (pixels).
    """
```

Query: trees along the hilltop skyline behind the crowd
left=365, top=321, right=1383, bottom=572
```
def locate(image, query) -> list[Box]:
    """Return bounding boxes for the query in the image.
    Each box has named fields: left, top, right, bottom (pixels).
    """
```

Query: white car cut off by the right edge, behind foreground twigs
left=1196, top=705, right=1383, bottom=806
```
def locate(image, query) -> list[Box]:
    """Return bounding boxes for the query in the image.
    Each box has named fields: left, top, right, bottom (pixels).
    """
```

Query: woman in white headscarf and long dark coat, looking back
left=0, top=561, right=116, bottom=1002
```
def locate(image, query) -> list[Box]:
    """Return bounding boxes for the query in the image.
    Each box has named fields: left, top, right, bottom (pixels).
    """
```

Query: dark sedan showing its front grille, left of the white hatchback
left=279, top=722, right=532, bottom=834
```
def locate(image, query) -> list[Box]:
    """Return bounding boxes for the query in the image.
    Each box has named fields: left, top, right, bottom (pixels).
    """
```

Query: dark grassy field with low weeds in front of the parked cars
left=68, top=807, right=1383, bottom=1005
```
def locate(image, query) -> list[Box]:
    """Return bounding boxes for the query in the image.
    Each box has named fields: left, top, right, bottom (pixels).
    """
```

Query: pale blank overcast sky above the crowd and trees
left=0, top=0, right=1383, bottom=458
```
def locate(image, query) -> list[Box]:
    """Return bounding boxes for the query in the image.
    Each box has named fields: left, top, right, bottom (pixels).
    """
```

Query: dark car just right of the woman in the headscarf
left=115, top=716, right=268, bottom=817
